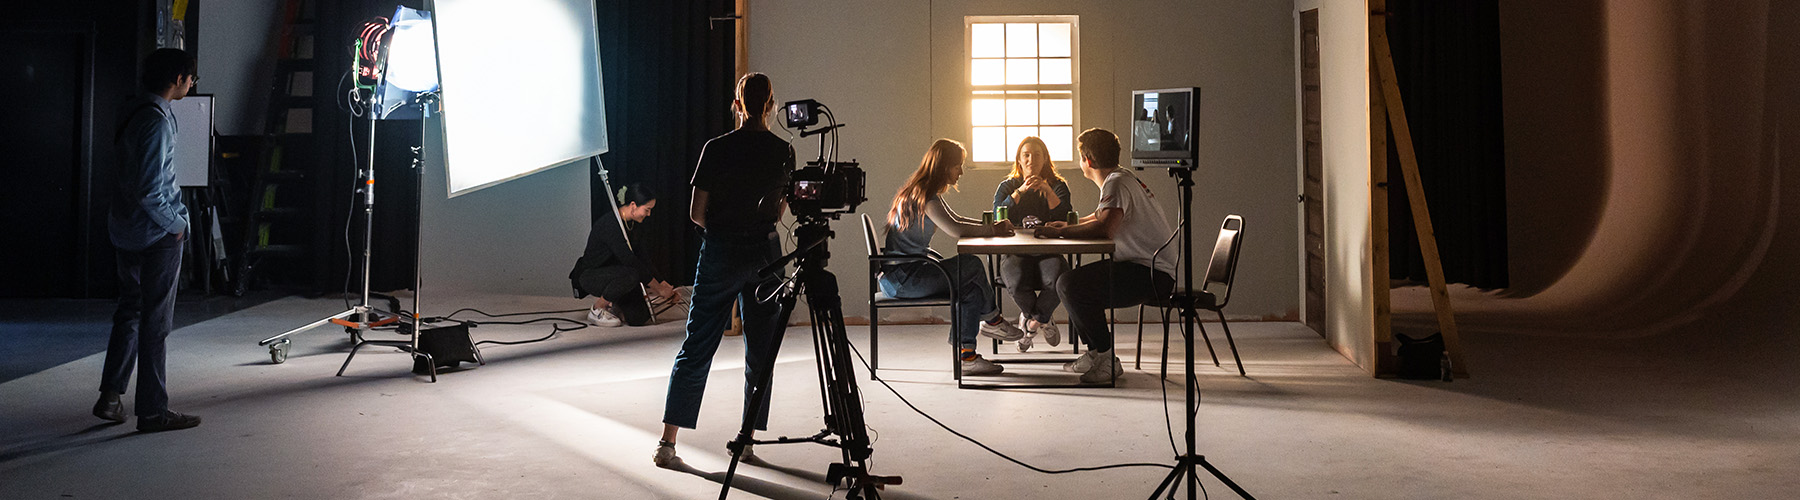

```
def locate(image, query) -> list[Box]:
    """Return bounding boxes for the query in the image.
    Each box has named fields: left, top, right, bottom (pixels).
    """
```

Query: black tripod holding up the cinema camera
left=718, top=216, right=900, bottom=500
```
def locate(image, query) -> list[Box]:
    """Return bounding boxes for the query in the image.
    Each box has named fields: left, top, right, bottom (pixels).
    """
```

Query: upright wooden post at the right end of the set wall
left=1366, top=0, right=1399, bottom=376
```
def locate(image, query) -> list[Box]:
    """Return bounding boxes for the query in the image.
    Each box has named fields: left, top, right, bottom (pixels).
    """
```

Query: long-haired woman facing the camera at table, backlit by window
left=994, top=137, right=1073, bottom=351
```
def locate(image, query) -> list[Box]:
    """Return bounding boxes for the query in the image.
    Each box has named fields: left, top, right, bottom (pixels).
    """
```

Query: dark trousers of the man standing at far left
left=101, top=234, right=182, bottom=417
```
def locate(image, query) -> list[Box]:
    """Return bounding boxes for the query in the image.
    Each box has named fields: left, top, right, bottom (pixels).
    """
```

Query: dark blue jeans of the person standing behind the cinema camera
left=662, top=230, right=787, bottom=430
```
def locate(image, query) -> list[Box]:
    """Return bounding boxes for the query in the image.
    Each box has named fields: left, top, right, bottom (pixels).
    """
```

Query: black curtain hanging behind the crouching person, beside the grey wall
left=590, top=0, right=736, bottom=284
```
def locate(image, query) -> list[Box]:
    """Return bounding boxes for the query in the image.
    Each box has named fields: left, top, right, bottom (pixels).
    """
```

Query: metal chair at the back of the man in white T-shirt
left=1132, top=214, right=1246, bottom=378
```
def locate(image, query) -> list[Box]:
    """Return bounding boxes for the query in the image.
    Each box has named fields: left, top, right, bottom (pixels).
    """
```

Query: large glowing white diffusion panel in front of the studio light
left=434, top=0, right=607, bottom=196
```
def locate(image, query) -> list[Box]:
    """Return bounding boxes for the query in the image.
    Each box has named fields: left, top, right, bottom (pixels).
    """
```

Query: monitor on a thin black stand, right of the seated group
left=1130, top=88, right=1201, bottom=167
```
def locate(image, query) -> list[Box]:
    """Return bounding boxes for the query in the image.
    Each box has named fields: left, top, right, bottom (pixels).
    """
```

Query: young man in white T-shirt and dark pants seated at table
left=1037, top=128, right=1175, bottom=383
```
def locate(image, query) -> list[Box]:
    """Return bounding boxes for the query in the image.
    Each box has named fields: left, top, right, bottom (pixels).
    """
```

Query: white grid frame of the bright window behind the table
left=958, top=14, right=1082, bottom=169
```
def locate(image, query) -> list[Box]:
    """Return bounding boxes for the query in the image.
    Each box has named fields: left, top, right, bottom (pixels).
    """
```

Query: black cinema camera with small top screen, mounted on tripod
left=781, top=99, right=868, bottom=219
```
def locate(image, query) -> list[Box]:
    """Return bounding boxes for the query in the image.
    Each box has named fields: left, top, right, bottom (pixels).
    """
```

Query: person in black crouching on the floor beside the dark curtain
left=569, top=183, right=677, bottom=327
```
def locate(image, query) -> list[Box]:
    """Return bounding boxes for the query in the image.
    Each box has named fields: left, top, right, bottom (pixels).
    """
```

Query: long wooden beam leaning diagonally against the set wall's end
left=1370, top=8, right=1469, bottom=376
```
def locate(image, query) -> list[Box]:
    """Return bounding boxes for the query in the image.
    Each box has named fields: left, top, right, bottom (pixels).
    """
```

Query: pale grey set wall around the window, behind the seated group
left=751, top=0, right=1300, bottom=318
